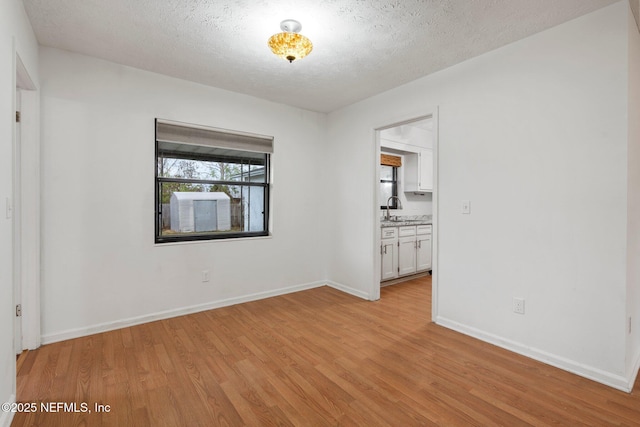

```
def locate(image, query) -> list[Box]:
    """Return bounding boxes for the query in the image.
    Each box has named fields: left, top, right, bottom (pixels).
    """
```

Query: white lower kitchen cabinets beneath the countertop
left=380, top=225, right=432, bottom=281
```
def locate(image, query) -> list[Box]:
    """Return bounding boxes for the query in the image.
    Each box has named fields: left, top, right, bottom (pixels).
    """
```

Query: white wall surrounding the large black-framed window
left=40, top=48, right=326, bottom=342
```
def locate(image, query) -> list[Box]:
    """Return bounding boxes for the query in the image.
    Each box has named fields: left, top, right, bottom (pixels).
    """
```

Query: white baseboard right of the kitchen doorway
left=436, top=316, right=633, bottom=393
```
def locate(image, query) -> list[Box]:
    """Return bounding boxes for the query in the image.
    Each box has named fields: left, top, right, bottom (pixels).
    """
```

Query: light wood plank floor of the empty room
left=12, top=277, right=640, bottom=427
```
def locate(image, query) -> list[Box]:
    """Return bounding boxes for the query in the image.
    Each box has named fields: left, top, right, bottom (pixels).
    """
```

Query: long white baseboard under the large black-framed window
left=42, top=281, right=330, bottom=344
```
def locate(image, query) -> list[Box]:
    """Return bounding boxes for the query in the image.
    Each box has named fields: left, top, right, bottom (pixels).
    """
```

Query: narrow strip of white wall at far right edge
left=626, top=2, right=640, bottom=382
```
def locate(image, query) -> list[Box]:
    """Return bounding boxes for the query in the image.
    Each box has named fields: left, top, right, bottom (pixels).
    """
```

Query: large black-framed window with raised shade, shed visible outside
left=155, top=119, right=273, bottom=243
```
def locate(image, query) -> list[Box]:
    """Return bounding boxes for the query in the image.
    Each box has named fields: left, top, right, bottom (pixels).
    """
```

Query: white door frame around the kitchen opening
left=370, top=106, right=440, bottom=322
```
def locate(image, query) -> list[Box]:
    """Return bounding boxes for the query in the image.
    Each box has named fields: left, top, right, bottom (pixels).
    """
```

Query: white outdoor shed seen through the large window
left=170, top=191, right=231, bottom=233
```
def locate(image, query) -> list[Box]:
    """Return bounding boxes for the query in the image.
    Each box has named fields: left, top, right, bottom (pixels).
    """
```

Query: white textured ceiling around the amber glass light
left=24, top=0, right=618, bottom=112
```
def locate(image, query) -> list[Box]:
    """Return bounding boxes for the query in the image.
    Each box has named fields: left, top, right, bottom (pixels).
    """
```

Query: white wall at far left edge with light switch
left=0, top=0, right=38, bottom=426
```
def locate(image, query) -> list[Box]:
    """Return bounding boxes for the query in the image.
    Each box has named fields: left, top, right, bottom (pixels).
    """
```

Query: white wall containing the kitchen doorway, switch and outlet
left=328, top=1, right=628, bottom=388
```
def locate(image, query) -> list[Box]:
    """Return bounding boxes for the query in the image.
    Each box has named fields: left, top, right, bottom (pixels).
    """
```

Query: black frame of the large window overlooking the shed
left=154, top=119, right=271, bottom=244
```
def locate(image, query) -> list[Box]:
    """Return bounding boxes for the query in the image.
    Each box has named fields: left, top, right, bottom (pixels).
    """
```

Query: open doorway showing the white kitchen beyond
left=372, top=109, right=438, bottom=317
